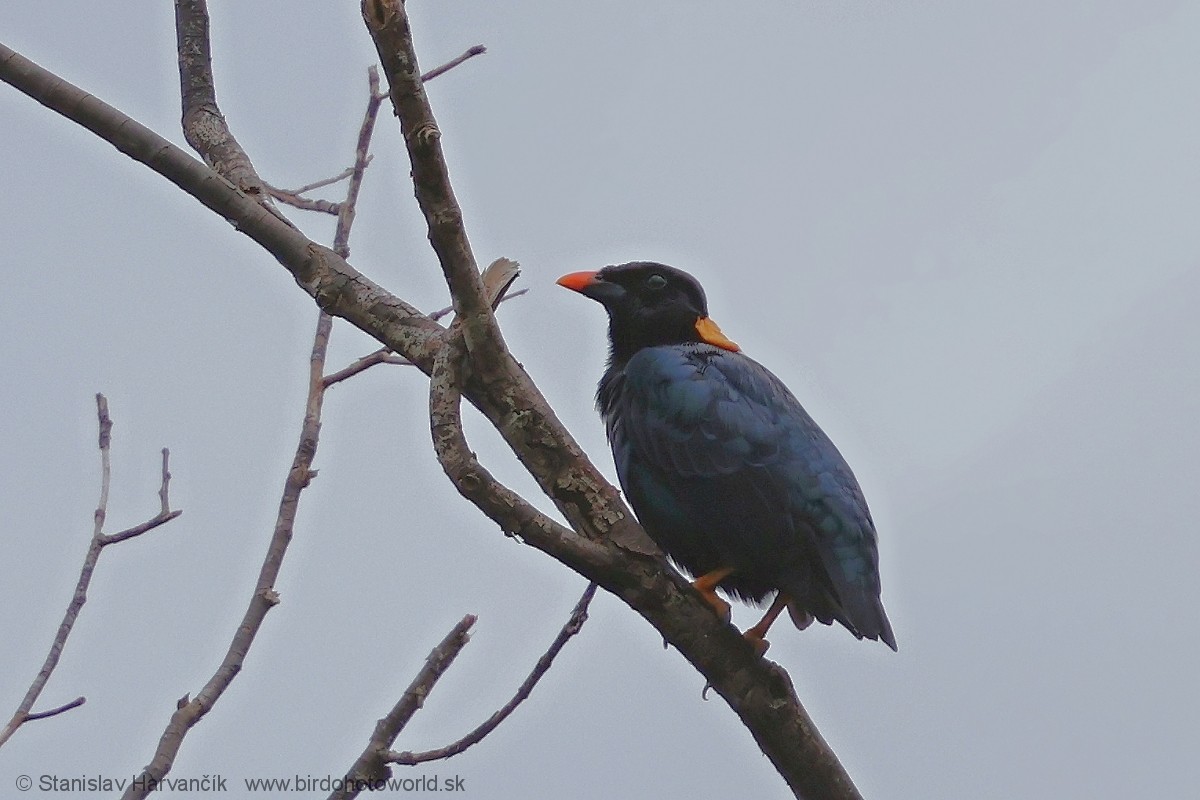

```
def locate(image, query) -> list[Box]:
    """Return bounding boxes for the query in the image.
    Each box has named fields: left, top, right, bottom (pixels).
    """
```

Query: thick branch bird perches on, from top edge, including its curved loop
left=362, top=0, right=859, bottom=799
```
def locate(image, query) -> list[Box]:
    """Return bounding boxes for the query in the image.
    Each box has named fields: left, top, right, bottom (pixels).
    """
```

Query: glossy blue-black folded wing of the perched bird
left=599, top=344, right=894, bottom=646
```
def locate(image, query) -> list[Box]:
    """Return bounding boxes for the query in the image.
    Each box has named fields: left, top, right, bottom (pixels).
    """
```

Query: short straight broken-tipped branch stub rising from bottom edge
left=329, top=614, right=475, bottom=800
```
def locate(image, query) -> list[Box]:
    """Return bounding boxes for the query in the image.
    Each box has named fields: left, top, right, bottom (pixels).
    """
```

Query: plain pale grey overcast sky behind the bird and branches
left=0, top=0, right=1200, bottom=800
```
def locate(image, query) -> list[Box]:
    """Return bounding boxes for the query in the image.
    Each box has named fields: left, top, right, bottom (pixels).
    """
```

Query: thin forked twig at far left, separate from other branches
left=0, top=393, right=184, bottom=747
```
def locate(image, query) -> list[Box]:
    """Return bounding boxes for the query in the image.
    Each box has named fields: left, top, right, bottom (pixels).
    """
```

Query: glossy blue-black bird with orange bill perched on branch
left=558, top=261, right=896, bottom=651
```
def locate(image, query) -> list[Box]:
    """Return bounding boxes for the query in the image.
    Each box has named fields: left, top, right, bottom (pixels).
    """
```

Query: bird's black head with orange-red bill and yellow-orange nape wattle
left=558, top=261, right=738, bottom=362
